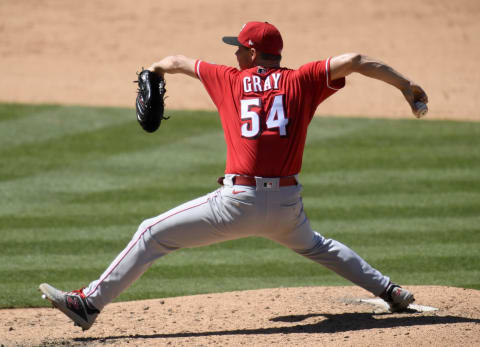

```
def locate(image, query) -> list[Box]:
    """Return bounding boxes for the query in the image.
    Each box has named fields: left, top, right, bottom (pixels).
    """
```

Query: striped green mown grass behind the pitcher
left=0, top=104, right=480, bottom=307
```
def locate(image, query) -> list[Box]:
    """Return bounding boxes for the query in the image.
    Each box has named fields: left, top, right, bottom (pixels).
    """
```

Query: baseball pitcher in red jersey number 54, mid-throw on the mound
left=40, top=22, right=428, bottom=330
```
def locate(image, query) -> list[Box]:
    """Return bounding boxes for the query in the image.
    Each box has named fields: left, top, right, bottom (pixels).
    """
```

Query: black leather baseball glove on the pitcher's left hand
left=134, top=68, right=169, bottom=133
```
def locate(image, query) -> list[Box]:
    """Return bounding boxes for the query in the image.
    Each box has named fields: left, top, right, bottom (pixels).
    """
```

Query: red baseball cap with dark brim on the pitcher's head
left=222, top=22, right=283, bottom=55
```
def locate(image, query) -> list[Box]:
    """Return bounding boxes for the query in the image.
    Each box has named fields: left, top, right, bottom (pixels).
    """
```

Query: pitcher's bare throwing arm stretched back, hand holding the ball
left=330, top=53, right=428, bottom=115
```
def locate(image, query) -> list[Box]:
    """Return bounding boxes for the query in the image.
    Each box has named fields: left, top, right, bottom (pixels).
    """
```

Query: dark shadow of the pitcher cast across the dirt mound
left=74, top=313, right=480, bottom=342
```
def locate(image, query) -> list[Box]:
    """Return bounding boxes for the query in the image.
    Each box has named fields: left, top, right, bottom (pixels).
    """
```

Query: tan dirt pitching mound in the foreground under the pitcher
left=0, top=286, right=480, bottom=347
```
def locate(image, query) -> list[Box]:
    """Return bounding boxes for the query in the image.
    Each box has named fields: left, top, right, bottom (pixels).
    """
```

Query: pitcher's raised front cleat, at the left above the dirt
left=39, top=283, right=100, bottom=331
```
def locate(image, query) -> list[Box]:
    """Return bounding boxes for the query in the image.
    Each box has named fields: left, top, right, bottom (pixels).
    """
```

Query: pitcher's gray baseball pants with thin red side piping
left=83, top=175, right=390, bottom=310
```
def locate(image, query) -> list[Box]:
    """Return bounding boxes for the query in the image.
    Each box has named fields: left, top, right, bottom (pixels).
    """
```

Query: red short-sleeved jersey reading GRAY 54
left=195, top=59, right=345, bottom=177
